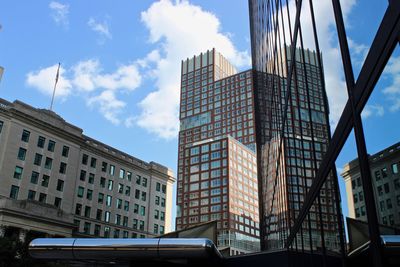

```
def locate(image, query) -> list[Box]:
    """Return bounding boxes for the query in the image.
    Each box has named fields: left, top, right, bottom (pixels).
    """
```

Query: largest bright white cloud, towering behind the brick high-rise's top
left=137, top=0, right=251, bottom=139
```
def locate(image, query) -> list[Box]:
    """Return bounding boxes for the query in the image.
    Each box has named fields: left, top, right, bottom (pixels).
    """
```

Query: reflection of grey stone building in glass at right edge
left=341, top=143, right=400, bottom=227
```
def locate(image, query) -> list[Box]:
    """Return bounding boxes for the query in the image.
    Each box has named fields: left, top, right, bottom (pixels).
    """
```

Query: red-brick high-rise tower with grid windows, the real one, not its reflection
left=176, top=49, right=259, bottom=254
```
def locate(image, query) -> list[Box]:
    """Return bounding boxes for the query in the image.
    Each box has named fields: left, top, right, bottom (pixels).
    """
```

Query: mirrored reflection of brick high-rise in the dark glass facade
left=249, top=0, right=340, bottom=250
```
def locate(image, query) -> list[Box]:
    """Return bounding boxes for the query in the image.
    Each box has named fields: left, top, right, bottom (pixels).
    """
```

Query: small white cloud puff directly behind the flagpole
left=26, top=64, right=72, bottom=98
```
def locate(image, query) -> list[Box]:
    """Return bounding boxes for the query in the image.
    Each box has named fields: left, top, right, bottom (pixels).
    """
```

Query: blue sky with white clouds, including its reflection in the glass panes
left=0, top=0, right=400, bottom=230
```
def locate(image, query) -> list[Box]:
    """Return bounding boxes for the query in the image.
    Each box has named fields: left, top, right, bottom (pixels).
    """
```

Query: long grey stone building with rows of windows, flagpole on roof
left=0, top=99, right=175, bottom=243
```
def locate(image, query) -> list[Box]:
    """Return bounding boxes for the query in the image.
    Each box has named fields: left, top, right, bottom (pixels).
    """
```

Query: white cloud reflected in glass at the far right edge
left=383, top=56, right=400, bottom=112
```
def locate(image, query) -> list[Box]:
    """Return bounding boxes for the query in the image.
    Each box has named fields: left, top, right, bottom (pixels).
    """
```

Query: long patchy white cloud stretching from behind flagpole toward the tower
left=26, top=59, right=142, bottom=125
